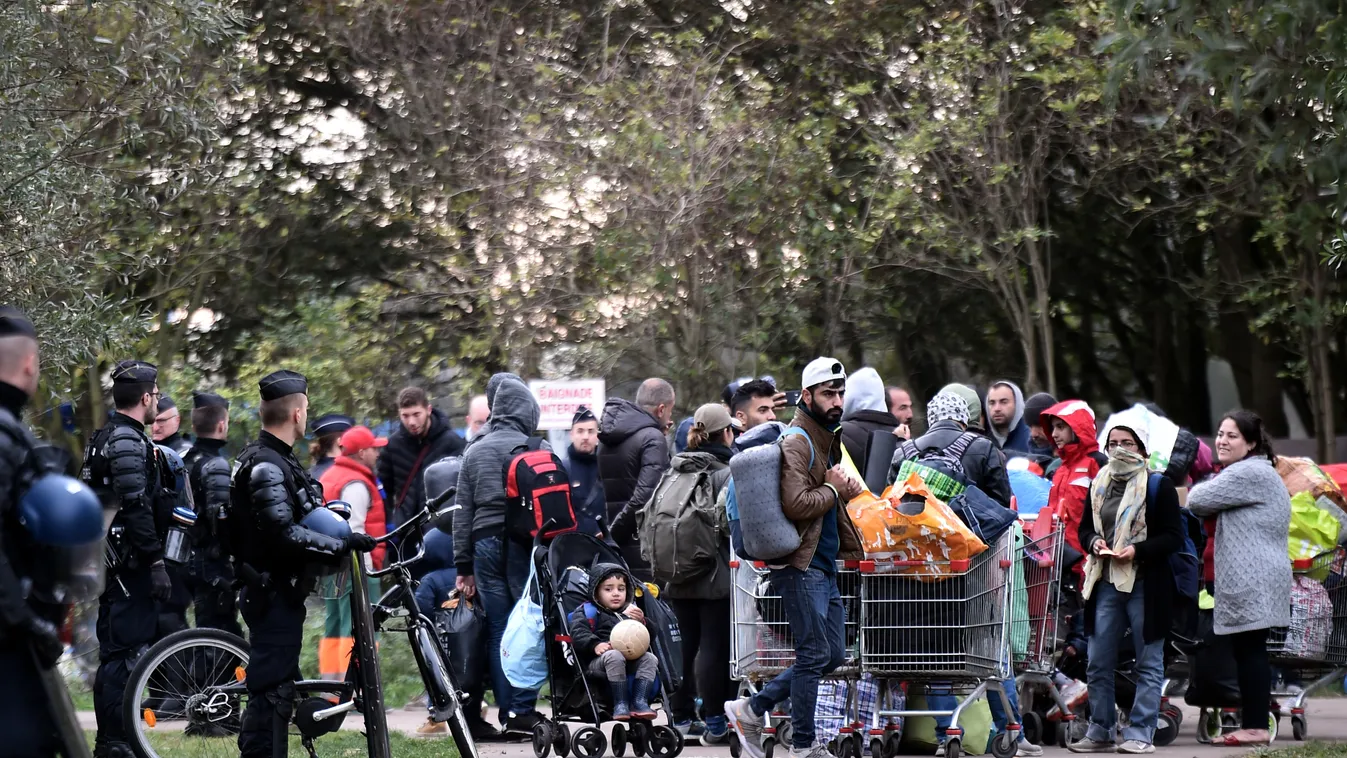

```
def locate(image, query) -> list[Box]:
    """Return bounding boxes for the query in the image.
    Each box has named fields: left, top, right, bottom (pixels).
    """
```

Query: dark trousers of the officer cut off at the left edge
left=0, top=641, right=62, bottom=758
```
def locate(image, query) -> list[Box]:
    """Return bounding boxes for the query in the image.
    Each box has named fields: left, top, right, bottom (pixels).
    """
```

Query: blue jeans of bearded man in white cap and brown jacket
left=752, top=568, right=846, bottom=750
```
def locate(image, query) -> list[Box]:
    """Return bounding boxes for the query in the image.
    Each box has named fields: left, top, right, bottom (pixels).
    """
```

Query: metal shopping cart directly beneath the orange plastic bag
left=855, top=533, right=1020, bottom=758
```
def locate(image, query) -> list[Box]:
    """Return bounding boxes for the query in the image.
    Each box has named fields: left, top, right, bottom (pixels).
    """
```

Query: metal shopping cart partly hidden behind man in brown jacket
left=730, top=556, right=861, bottom=758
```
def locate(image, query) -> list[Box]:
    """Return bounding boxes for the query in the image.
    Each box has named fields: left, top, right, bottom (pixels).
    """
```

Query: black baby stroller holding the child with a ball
left=533, top=532, right=683, bottom=758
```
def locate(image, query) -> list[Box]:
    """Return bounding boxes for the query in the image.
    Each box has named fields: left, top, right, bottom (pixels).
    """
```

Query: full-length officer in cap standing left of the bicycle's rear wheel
left=82, top=361, right=172, bottom=758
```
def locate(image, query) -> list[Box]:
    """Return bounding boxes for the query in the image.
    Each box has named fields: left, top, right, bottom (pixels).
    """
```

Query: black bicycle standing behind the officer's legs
left=123, top=490, right=478, bottom=758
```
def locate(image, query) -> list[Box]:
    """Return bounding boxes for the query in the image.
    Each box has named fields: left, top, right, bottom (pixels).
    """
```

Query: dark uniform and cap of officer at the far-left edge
left=0, top=307, right=63, bottom=755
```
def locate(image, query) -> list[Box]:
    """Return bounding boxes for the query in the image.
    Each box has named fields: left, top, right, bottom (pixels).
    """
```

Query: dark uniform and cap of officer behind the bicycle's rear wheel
left=183, top=392, right=242, bottom=637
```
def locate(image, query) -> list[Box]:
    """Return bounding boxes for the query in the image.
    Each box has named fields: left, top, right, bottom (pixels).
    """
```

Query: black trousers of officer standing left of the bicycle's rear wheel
left=93, top=567, right=159, bottom=751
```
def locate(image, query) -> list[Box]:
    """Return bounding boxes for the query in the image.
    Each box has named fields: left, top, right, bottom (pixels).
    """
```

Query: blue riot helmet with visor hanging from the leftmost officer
left=19, top=474, right=117, bottom=605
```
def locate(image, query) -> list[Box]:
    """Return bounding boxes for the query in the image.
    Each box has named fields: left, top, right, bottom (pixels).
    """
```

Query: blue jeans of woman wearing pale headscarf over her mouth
left=1086, top=579, right=1165, bottom=745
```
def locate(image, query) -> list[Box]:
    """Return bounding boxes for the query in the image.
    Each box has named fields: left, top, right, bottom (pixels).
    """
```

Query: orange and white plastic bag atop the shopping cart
left=846, top=474, right=987, bottom=575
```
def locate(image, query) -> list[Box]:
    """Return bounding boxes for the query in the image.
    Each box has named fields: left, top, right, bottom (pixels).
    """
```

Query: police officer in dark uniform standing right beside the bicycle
left=228, top=370, right=374, bottom=758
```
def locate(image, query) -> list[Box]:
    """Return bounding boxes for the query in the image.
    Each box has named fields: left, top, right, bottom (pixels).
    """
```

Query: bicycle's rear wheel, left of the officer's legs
left=121, top=629, right=248, bottom=758
